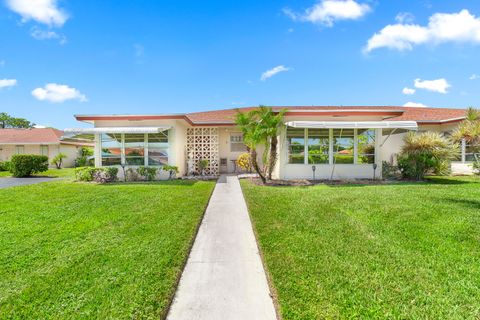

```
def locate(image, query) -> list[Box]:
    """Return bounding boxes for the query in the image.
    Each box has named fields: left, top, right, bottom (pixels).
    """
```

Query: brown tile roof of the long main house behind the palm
left=186, top=106, right=465, bottom=124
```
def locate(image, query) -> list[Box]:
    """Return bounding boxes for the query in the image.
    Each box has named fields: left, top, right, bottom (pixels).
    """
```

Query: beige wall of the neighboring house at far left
left=0, top=144, right=80, bottom=168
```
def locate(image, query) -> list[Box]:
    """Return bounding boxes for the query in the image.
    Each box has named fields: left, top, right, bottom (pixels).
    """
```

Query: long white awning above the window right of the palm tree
left=285, top=121, right=418, bottom=130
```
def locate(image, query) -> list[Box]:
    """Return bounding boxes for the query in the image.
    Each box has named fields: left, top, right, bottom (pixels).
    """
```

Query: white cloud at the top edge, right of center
left=283, top=0, right=371, bottom=27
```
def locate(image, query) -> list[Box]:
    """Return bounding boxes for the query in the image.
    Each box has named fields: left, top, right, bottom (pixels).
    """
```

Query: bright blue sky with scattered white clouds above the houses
left=0, top=0, right=480, bottom=129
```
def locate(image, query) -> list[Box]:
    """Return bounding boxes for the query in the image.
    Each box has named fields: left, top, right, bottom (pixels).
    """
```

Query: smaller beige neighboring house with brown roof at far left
left=0, top=128, right=93, bottom=167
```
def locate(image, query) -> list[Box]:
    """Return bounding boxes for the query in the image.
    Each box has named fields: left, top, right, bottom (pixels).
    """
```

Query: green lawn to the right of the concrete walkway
left=242, top=177, right=480, bottom=320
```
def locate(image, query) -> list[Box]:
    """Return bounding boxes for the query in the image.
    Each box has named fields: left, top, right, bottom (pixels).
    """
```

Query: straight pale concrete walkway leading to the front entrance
left=167, top=176, right=276, bottom=320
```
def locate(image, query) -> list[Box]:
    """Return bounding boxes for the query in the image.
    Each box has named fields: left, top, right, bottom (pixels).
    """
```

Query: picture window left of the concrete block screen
left=101, top=132, right=168, bottom=166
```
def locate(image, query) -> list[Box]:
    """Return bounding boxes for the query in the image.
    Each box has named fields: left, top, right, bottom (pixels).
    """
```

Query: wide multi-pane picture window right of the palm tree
left=287, top=127, right=376, bottom=164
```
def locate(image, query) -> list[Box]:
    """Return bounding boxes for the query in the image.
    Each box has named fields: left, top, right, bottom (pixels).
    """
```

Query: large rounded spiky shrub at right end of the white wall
left=398, top=132, right=459, bottom=180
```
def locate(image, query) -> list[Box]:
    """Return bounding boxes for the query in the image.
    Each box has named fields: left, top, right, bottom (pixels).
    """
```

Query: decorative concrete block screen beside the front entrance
left=187, top=128, right=219, bottom=175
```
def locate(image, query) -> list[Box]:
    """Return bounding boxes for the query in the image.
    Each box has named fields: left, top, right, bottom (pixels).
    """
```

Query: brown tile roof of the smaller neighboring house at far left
left=0, top=128, right=63, bottom=144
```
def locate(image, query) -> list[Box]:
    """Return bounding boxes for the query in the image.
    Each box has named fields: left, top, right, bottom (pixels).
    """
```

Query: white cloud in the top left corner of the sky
left=7, top=0, right=68, bottom=27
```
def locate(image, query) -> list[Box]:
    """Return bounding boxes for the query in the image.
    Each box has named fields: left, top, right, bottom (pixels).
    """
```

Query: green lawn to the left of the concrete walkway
left=0, top=181, right=214, bottom=319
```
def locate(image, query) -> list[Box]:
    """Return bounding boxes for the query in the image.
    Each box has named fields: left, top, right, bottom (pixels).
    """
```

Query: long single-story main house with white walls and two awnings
left=66, top=106, right=473, bottom=179
